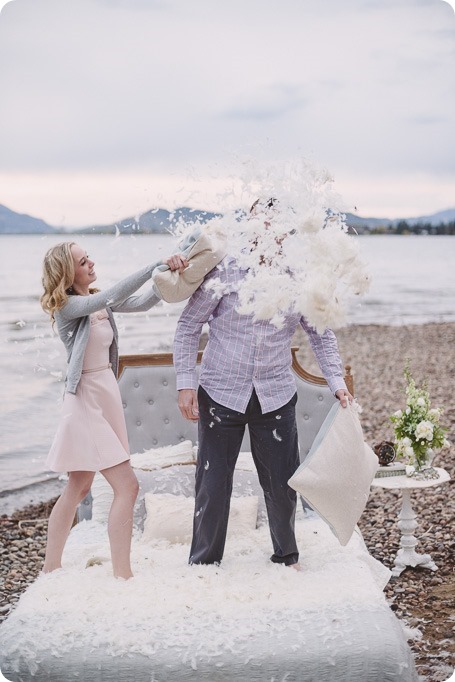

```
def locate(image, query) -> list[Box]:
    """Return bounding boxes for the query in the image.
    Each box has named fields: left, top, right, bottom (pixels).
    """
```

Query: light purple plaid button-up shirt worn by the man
left=174, top=258, right=346, bottom=413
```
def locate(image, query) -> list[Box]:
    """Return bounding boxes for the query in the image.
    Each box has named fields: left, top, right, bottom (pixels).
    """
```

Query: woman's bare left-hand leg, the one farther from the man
left=43, top=471, right=95, bottom=573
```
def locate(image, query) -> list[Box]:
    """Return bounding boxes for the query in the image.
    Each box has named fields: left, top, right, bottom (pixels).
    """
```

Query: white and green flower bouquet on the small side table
left=390, top=366, right=450, bottom=471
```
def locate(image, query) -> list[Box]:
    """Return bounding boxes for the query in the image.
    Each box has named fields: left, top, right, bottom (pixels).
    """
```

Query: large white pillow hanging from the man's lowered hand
left=288, top=401, right=379, bottom=545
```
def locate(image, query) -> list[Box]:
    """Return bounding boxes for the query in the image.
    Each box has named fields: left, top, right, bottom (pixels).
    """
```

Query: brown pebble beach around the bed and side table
left=0, top=323, right=455, bottom=682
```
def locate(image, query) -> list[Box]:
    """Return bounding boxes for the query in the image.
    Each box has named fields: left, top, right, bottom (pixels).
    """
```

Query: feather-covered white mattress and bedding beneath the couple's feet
left=0, top=519, right=417, bottom=682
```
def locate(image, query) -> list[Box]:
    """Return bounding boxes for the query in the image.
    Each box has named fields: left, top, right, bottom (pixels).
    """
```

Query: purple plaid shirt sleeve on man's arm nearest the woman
left=174, top=268, right=223, bottom=391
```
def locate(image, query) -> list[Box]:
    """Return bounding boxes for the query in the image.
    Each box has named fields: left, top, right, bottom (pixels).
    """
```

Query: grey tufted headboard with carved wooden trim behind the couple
left=118, top=347, right=353, bottom=457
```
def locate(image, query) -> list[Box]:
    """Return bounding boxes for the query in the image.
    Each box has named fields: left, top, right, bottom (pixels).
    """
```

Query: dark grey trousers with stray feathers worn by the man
left=189, top=387, right=300, bottom=566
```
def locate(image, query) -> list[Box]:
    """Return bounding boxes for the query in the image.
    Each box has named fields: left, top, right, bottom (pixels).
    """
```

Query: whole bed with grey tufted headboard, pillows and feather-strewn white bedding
left=0, top=350, right=417, bottom=682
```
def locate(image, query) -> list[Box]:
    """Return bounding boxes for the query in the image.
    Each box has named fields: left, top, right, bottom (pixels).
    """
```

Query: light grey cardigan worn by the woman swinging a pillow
left=55, top=229, right=200, bottom=393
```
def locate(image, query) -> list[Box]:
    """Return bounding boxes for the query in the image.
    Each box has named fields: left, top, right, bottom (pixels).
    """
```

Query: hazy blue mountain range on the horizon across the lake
left=0, top=204, right=455, bottom=234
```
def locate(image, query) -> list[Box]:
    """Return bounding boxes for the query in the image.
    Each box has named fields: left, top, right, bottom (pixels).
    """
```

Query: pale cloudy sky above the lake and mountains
left=0, top=0, right=455, bottom=226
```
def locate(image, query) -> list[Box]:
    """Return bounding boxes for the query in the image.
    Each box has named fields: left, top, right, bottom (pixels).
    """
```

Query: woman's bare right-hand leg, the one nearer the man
left=101, top=460, right=139, bottom=579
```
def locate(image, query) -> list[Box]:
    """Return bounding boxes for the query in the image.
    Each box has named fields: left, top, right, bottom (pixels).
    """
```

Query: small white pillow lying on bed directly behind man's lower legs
left=142, top=493, right=258, bottom=544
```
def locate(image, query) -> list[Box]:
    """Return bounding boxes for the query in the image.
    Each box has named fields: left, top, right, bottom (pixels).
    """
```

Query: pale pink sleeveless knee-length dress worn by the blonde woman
left=46, top=310, right=129, bottom=472
